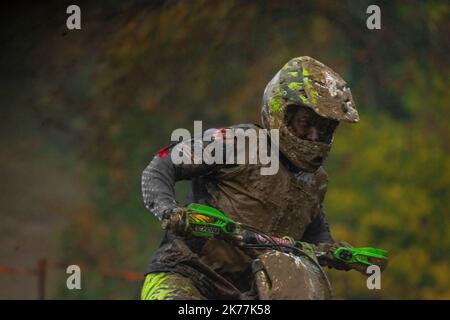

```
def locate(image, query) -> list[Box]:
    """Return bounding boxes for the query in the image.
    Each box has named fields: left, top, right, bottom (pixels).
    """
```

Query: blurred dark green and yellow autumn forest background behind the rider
left=0, top=0, right=450, bottom=299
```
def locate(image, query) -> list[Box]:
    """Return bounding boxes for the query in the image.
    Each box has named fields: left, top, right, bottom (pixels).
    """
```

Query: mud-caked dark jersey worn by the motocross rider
left=142, top=124, right=333, bottom=299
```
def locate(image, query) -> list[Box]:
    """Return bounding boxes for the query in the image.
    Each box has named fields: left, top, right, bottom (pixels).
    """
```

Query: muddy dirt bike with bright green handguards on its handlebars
left=172, top=203, right=388, bottom=300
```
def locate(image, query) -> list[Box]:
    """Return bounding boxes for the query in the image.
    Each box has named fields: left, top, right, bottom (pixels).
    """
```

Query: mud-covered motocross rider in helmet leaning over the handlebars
left=141, top=56, right=376, bottom=300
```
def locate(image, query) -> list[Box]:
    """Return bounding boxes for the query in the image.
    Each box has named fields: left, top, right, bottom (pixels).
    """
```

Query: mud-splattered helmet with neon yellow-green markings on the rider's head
left=262, top=56, right=359, bottom=172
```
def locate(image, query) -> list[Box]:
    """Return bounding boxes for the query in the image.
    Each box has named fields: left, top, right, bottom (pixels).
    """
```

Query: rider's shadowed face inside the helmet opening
left=287, top=106, right=338, bottom=143
